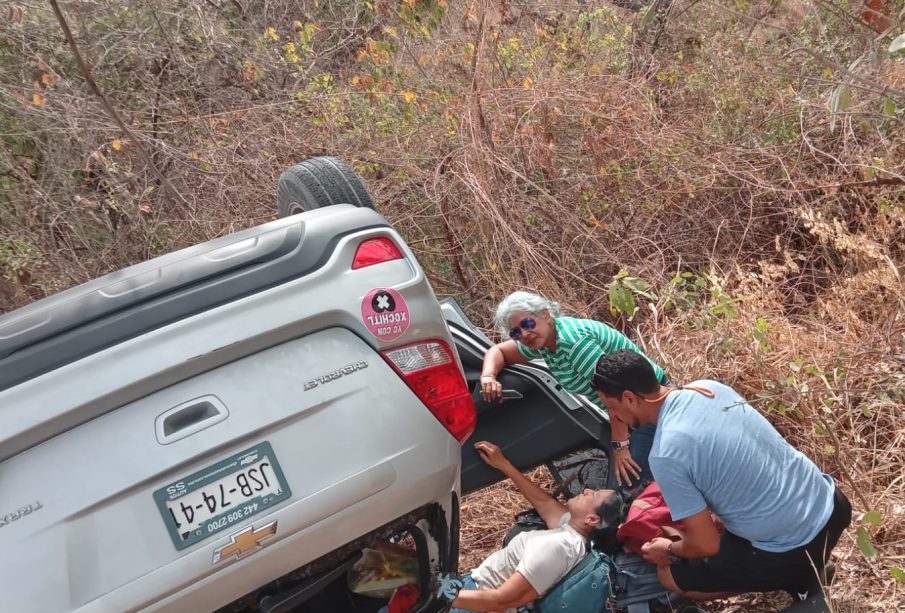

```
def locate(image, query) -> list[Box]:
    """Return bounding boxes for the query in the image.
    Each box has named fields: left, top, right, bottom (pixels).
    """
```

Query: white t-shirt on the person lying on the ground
left=471, top=513, right=588, bottom=611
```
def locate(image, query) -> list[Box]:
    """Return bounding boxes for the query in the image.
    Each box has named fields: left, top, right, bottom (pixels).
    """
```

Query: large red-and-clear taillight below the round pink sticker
left=383, top=340, right=477, bottom=443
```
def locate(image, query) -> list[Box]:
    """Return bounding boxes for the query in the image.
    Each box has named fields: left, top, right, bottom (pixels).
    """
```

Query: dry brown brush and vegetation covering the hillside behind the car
left=0, top=0, right=905, bottom=611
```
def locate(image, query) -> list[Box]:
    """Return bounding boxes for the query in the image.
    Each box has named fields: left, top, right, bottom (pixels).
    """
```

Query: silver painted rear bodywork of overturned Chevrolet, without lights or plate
left=0, top=205, right=460, bottom=611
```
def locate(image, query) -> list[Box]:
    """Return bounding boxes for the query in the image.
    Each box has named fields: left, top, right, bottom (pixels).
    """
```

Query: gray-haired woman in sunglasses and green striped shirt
left=481, top=292, right=669, bottom=485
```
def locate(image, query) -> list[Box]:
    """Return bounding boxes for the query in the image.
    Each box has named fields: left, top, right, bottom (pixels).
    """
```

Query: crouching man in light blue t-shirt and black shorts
left=592, top=351, right=852, bottom=600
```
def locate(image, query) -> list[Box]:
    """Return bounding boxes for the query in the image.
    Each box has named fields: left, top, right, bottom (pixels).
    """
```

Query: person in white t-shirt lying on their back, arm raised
left=438, top=441, right=623, bottom=613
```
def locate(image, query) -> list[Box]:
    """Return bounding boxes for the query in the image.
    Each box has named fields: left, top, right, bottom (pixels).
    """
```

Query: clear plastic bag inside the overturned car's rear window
left=348, top=543, right=418, bottom=598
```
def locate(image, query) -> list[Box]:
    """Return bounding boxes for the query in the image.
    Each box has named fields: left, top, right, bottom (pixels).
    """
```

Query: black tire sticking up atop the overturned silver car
left=277, top=157, right=374, bottom=217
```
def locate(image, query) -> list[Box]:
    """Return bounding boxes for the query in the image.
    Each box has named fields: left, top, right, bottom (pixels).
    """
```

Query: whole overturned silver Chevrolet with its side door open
left=0, top=158, right=609, bottom=613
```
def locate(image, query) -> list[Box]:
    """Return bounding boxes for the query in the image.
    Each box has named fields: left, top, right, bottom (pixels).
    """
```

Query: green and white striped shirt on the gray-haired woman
left=516, top=317, right=663, bottom=411
